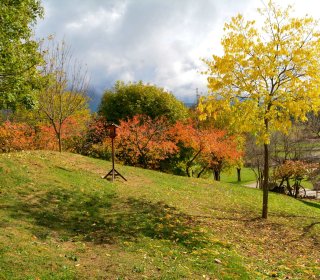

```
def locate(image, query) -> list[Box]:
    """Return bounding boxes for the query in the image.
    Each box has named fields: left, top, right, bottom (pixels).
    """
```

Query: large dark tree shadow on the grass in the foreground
left=12, top=189, right=207, bottom=250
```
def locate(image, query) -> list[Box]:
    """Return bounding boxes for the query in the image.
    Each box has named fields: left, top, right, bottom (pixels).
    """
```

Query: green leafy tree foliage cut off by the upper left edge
left=0, top=0, right=43, bottom=110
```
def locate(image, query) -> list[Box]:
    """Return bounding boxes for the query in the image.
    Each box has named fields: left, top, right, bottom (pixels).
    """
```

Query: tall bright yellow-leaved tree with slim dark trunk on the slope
left=199, top=1, right=320, bottom=218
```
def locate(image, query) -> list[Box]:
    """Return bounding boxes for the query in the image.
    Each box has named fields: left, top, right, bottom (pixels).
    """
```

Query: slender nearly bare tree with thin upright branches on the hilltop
left=39, top=39, right=89, bottom=152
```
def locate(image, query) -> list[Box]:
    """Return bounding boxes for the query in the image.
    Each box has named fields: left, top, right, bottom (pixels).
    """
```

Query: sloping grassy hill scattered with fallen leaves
left=0, top=151, right=320, bottom=279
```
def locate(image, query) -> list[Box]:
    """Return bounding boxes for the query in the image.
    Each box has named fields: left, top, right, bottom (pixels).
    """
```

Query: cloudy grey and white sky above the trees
left=35, top=0, right=320, bottom=109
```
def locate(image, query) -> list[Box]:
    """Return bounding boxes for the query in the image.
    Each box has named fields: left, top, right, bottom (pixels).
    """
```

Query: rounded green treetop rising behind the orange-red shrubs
left=99, top=81, right=188, bottom=123
